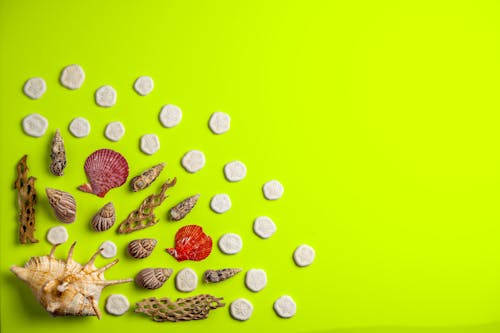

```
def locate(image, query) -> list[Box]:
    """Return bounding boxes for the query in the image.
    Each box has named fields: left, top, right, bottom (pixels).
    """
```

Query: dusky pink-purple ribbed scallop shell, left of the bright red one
left=78, top=149, right=128, bottom=198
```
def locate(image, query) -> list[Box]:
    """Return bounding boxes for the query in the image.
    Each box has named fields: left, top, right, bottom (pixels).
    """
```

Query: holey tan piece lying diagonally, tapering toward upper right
left=118, top=178, right=177, bottom=234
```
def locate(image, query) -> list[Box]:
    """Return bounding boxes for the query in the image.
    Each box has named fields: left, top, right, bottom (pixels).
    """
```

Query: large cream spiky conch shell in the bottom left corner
left=10, top=242, right=133, bottom=319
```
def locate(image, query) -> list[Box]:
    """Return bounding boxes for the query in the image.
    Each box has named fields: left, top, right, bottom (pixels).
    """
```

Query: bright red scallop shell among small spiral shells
left=166, top=225, right=212, bottom=261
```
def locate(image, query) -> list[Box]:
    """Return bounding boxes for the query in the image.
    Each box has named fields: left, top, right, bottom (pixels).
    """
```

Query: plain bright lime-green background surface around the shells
left=0, top=0, right=500, bottom=333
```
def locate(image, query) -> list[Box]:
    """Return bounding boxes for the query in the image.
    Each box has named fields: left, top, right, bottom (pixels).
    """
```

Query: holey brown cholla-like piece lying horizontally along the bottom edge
left=134, top=294, right=225, bottom=322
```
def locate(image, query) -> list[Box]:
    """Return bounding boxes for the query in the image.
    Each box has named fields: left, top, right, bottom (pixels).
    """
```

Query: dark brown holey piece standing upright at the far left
left=14, top=155, right=38, bottom=244
